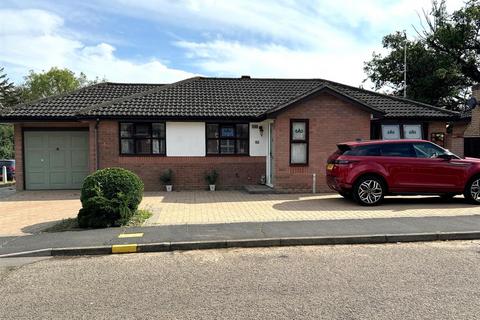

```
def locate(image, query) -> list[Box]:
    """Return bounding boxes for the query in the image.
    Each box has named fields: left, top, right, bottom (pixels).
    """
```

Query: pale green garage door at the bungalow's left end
left=24, top=131, right=88, bottom=190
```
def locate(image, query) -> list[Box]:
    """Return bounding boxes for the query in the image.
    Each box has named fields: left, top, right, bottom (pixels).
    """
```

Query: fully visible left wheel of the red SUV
left=353, top=176, right=386, bottom=206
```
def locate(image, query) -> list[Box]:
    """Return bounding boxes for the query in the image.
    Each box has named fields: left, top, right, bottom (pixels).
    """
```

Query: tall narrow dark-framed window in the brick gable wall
left=290, top=120, right=308, bottom=165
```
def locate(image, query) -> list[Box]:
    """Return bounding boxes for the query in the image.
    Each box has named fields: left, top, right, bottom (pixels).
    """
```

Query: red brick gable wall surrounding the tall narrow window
left=274, top=94, right=370, bottom=192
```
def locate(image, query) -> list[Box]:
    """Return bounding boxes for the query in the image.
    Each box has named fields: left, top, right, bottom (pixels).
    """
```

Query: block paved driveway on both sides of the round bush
left=0, top=190, right=480, bottom=237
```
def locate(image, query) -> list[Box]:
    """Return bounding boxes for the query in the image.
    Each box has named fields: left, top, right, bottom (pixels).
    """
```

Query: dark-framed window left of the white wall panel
left=120, top=122, right=166, bottom=155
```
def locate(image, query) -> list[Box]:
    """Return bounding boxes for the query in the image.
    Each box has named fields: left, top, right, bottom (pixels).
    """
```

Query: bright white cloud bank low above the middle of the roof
left=177, top=40, right=368, bottom=85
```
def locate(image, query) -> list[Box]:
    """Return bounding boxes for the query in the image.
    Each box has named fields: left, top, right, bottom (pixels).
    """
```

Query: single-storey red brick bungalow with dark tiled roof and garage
left=0, top=76, right=480, bottom=191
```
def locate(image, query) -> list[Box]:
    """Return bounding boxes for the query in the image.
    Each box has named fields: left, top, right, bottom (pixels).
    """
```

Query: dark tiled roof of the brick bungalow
left=0, top=77, right=460, bottom=121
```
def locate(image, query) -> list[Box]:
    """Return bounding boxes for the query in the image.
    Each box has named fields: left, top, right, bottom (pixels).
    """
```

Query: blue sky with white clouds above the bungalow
left=0, top=0, right=463, bottom=86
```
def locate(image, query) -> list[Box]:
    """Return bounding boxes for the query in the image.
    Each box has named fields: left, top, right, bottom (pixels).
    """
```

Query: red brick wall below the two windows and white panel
left=95, top=121, right=265, bottom=190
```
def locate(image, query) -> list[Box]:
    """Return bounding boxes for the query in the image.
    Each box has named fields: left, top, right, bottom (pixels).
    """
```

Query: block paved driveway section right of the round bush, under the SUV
left=142, top=191, right=480, bottom=225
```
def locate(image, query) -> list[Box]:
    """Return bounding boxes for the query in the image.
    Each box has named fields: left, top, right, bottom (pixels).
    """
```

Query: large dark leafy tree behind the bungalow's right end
left=364, top=0, right=480, bottom=109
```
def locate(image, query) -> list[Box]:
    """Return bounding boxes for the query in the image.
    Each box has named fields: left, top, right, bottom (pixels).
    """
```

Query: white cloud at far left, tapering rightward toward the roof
left=0, top=10, right=197, bottom=83
